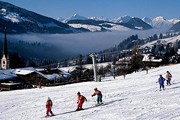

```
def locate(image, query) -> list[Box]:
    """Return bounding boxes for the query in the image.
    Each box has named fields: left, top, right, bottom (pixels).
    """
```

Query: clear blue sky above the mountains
left=2, top=0, right=180, bottom=19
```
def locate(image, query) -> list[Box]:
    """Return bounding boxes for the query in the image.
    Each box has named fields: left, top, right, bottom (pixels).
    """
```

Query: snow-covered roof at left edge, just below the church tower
left=0, top=69, right=17, bottom=80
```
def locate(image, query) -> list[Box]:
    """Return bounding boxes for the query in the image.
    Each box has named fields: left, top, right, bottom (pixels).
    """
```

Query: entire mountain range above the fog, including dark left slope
left=0, top=1, right=180, bottom=34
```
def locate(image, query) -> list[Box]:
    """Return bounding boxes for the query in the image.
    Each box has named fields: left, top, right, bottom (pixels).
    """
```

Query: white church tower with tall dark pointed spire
left=0, top=29, right=9, bottom=70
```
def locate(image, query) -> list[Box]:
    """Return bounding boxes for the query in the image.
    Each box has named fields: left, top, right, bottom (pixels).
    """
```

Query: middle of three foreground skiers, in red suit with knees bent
left=76, top=92, right=87, bottom=111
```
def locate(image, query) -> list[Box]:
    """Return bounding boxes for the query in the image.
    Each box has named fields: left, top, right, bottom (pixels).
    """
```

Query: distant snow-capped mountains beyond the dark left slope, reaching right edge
left=61, top=14, right=180, bottom=32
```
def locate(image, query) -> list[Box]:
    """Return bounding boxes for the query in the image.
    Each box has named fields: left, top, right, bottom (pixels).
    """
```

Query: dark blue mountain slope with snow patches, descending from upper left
left=0, top=1, right=87, bottom=34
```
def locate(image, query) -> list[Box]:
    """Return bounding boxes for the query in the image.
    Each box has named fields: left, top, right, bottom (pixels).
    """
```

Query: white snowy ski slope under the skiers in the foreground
left=0, top=64, right=180, bottom=120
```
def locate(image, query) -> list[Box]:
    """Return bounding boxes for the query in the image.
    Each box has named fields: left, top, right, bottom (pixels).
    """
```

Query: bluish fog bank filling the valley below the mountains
left=0, top=29, right=167, bottom=59
